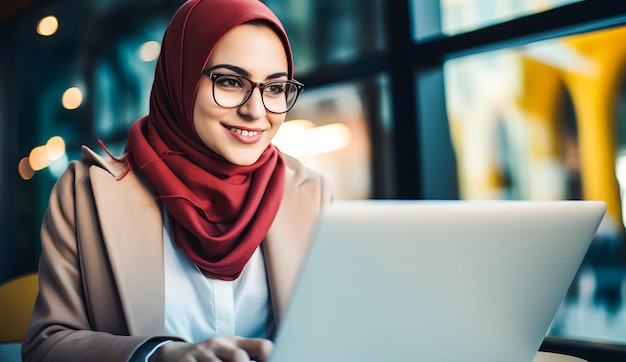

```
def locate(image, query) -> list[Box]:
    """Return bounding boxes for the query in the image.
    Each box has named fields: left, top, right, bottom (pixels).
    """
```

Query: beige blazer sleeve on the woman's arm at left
left=22, top=161, right=150, bottom=361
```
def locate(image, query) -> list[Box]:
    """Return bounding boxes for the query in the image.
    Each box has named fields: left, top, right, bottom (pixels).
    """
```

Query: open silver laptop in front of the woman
left=269, top=200, right=606, bottom=362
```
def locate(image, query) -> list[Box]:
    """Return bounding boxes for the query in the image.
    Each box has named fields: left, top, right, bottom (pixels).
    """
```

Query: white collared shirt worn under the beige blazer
left=163, top=212, right=274, bottom=343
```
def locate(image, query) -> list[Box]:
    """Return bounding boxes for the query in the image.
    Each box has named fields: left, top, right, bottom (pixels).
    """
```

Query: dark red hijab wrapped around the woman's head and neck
left=128, top=0, right=293, bottom=280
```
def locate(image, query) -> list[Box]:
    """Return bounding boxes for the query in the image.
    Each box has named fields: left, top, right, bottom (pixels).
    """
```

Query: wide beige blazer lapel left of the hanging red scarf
left=89, top=167, right=165, bottom=335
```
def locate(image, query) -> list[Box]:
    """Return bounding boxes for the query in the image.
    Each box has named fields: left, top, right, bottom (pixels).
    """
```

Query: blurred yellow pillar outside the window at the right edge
left=563, top=29, right=626, bottom=222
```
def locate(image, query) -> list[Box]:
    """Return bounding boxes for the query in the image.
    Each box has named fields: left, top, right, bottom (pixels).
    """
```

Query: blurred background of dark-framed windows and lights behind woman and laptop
left=0, top=0, right=626, bottom=356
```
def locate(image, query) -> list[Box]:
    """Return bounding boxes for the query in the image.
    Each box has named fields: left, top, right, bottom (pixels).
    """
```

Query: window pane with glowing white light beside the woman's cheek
left=280, top=82, right=380, bottom=199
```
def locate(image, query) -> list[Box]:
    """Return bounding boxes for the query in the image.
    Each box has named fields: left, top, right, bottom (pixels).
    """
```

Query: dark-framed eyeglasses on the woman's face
left=203, top=71, right=304, bottom=114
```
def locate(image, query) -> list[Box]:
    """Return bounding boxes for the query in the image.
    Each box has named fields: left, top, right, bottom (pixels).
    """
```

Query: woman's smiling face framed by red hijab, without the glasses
left=193, top=24, right=288, bottom=166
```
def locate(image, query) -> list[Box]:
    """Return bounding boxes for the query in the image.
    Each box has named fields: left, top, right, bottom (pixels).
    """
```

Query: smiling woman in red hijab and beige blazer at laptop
left=22, top=0, right=331, bottom=361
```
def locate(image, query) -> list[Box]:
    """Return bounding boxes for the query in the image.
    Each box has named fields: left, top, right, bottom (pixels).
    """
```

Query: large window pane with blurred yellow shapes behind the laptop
left=444, top=14, right=626, bottom=344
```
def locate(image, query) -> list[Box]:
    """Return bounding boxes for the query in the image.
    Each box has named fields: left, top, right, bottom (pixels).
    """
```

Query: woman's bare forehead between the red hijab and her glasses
left=207, top=24, right=288, bottom=75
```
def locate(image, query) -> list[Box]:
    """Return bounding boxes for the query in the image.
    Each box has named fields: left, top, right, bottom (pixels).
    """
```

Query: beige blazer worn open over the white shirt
left=22, top=147, right=331, bottom=361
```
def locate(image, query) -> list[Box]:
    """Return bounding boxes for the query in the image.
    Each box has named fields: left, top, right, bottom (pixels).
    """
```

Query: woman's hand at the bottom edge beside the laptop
left=150, top=336, right=274, bottom=362
